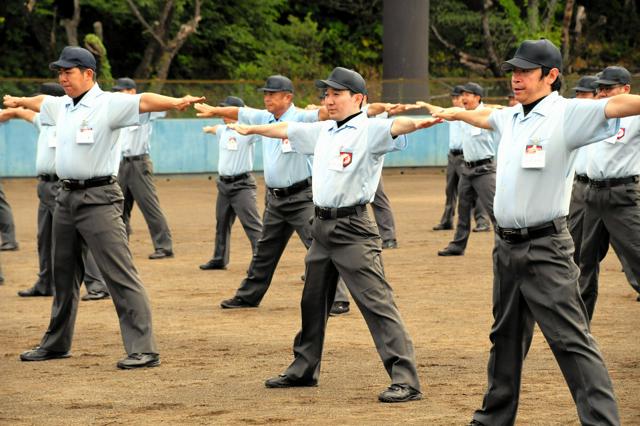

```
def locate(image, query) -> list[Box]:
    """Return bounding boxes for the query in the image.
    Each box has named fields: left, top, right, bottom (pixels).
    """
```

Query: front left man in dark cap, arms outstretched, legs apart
left=4, top=46, right=204, bottom=369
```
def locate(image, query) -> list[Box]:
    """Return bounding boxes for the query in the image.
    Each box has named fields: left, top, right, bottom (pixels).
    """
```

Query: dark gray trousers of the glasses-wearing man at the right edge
left=580, top=183, right=640, bottom=319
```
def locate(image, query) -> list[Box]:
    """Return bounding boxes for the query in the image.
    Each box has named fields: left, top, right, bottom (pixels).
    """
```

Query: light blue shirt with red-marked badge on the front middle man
left=287, top=114, right=407, bottom=208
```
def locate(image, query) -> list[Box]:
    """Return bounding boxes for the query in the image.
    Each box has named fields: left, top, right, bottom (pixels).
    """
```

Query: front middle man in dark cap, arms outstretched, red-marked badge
left=228, top=67, right=439, bottom=402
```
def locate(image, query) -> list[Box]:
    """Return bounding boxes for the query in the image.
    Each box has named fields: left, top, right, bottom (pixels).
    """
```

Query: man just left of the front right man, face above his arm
left=438, top=82, right=496, bottom=256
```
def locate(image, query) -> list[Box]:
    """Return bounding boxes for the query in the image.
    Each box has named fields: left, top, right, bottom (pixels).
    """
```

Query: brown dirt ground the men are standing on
left=0, top=169, right=640, bottom=425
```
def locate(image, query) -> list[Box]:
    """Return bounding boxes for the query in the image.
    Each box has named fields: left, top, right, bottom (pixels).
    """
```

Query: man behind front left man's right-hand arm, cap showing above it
left=111, top=77, right=173, bottom=259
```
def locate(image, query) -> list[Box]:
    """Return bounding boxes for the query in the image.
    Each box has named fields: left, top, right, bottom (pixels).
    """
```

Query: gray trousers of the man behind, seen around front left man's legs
left=34, top=180, right=108, bottom=294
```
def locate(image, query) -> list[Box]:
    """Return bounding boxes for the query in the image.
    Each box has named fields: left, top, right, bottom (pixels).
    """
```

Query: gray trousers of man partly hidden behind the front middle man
left=236, top=186, right=349, bottom=306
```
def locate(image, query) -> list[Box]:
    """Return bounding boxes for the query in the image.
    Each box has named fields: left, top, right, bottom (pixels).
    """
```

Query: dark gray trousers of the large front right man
left=473, top=223, right=620, bottom=425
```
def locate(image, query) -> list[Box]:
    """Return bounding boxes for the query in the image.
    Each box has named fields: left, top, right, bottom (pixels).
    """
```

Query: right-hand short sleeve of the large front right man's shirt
left=563, top=99, right=620, bottom=149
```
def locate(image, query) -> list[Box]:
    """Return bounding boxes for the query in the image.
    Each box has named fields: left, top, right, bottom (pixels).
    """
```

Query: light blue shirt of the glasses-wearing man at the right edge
left=587, top=115, right=640, bottom=180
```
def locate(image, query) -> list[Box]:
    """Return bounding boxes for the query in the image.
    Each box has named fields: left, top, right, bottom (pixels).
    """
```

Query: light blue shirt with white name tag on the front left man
left=40, top=84, right=140, bottom=180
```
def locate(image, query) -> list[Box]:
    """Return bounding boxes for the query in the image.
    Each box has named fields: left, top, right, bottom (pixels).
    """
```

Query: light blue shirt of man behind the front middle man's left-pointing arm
left=238, top=104, right=318, bottom=188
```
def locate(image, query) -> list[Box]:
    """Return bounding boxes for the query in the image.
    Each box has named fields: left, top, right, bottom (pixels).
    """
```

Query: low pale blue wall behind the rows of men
left=0, top=119, right=449, bottom=177
